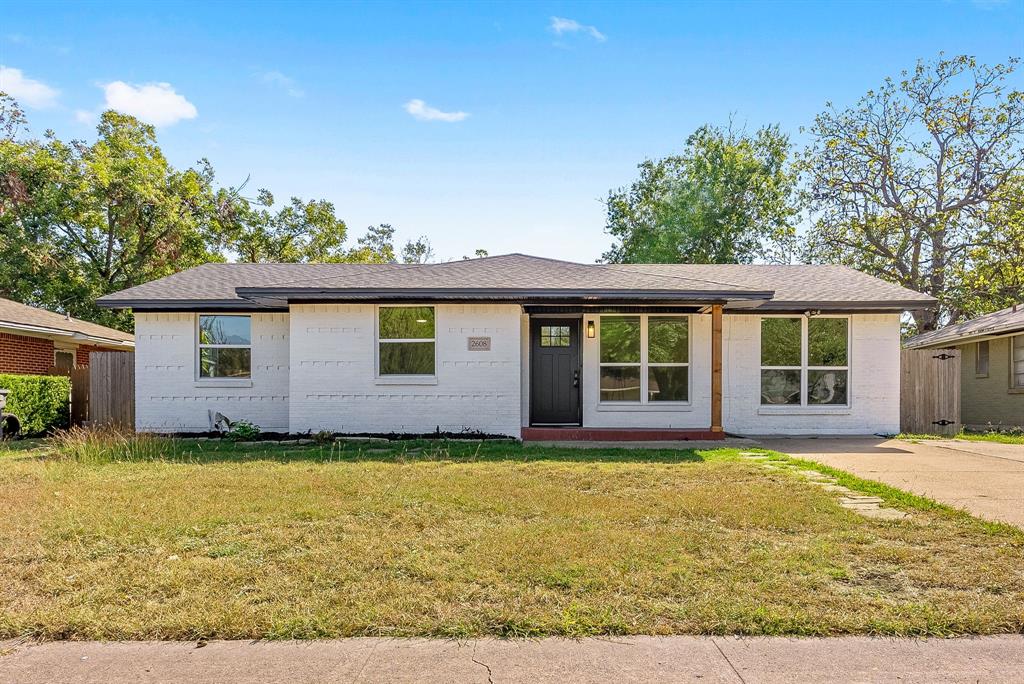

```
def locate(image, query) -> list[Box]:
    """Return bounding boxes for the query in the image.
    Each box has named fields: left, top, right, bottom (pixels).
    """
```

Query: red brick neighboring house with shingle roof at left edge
left=0, top=298, right=135, bottom=375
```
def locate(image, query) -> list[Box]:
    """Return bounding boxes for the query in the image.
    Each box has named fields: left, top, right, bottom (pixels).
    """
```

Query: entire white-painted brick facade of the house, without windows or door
left=135, top=304, right=899, bottom=436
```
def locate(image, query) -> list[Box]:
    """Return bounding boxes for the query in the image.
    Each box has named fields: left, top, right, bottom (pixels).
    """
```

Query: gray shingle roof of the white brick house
left=99, top=254, right=934, bottom=310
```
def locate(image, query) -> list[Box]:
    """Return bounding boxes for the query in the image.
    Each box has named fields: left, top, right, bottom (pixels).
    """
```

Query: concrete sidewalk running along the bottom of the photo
left=0, top=636, right=1024, bottom=684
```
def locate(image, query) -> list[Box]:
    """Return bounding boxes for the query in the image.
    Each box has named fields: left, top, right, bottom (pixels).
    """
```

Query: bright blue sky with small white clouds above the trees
left=0, top=0, right=1024, bottom=261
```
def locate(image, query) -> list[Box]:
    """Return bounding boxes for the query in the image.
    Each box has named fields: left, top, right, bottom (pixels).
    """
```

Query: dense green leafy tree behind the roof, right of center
left=604, top=126, right=797, bottom=263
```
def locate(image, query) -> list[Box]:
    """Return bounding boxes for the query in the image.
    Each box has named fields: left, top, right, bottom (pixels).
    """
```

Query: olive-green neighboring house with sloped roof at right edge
left=905, top=304, right=1024, bottom=429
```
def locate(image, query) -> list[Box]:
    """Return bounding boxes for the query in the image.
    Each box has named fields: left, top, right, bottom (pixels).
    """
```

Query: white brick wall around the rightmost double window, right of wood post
left=722, top=313, right=900, bottom=435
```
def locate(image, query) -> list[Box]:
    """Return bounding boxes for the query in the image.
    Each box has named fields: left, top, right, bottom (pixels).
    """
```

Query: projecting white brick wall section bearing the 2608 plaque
left=289, top=304, right=522, bottom=437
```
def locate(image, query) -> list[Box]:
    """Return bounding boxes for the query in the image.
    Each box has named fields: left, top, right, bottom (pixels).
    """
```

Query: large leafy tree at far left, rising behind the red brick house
left=0, top=112, right=219, bottom=328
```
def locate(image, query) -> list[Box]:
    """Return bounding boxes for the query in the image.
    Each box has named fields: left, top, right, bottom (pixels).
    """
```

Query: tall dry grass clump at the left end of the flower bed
left=49, top=425, right=177, bottom=464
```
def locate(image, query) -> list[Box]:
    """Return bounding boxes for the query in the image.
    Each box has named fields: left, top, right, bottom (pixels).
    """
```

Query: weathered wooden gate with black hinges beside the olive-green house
left=899, top=349, right=962, bottom=435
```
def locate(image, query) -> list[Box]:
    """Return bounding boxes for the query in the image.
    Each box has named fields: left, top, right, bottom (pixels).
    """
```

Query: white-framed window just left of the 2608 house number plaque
left=377, top=306, right=434, bottom=376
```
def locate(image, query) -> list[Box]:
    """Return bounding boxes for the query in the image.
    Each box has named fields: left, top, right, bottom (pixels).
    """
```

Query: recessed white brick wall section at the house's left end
left=135, top=313, right=289, bottom=432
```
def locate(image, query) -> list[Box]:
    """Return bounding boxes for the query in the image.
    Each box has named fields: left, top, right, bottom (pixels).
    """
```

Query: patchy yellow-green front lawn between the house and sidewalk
left=0, top=440, right=1024, bottom=639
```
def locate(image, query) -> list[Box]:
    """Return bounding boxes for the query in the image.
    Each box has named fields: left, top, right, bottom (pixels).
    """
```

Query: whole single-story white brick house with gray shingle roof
left=100, top=255, right=933, bottom=439
